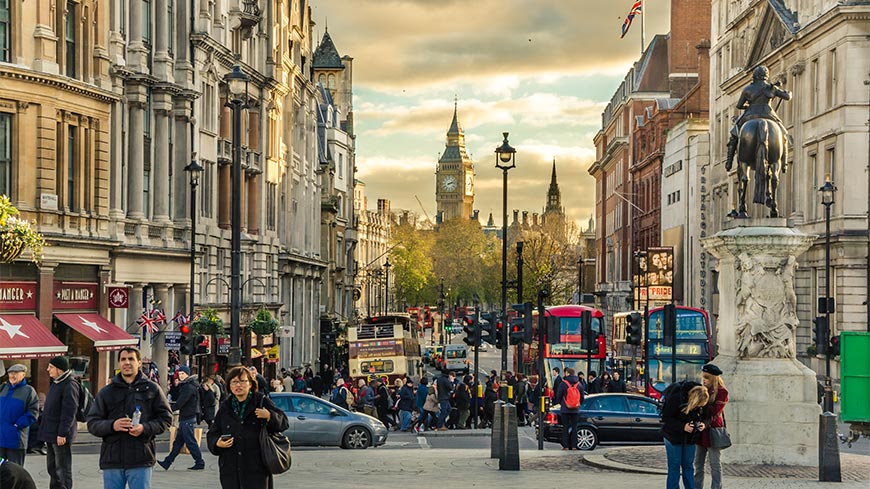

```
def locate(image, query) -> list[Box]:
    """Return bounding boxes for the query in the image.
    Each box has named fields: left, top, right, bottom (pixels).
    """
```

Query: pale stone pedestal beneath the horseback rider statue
left=702, top=219, right=821, bottom=466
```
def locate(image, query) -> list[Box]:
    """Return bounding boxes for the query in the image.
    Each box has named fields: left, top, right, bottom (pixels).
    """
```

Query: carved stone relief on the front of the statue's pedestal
left=736, top=253, right=798, bottom=358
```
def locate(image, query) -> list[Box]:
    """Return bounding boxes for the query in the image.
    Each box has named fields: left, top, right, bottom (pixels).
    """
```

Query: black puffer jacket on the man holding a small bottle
left=88, top=372, right=172, bottom=470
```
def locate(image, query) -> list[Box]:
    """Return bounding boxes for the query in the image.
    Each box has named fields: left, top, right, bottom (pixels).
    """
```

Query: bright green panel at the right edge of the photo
left=840, top=331, right=870, bottom=423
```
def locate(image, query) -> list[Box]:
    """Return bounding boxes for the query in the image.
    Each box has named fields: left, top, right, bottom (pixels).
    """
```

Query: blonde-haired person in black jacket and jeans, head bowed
left=662, top=381, right=709, bottom=489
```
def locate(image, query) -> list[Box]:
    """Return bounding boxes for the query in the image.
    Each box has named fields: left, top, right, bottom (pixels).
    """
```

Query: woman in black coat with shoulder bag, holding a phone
left=207, top=367, right=290, bottom=489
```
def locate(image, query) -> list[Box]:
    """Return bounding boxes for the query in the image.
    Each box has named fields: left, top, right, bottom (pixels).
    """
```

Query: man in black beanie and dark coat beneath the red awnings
left=39, top=357, right=81, bottom=489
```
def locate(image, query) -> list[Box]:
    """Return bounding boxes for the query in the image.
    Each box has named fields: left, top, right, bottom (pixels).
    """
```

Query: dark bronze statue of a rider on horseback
left=725, top=66, right=791, bottom=218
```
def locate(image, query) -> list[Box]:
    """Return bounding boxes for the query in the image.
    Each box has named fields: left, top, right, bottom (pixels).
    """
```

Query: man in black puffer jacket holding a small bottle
left=88, top=346, right=172, bottom=489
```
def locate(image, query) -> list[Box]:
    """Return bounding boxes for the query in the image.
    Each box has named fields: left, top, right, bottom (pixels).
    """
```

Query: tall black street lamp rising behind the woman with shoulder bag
left=224, top=65, right=250, bottom=365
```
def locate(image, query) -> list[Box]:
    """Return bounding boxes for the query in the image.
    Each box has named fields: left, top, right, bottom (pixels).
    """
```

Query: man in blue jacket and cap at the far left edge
left=0, top=363, right=39, bottom=466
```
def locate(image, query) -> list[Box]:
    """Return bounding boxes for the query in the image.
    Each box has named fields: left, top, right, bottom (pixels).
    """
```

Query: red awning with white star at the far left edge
left=0, top=314, right=67, bottom=359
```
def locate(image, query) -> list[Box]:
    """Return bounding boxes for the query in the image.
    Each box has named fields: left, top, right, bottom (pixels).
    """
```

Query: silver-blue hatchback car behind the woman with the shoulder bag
left=270, top=392, right=388, bottom=448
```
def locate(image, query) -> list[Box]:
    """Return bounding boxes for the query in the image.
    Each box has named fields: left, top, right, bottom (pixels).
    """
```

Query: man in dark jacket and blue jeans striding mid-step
left=157, top=365, right=205, bottom=470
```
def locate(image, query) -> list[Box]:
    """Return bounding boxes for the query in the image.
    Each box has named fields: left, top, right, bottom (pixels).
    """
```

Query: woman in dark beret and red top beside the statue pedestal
left=695, top=363, right=731, bottom=489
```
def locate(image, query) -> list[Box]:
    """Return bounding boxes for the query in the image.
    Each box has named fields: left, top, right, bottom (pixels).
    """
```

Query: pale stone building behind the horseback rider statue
left=702, top=0, right=870, bottom=378
